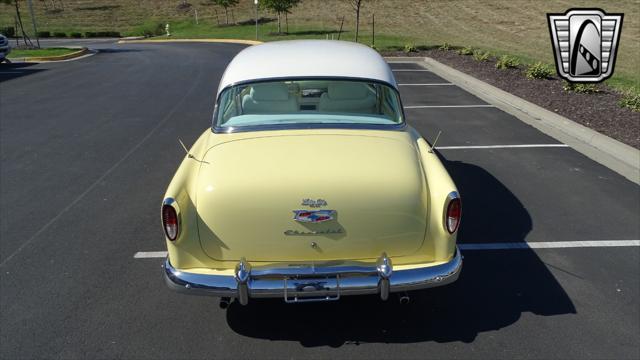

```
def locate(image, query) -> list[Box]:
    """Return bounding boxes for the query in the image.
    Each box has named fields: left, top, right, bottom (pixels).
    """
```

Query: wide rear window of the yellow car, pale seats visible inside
left=214, top=79, right=403, bottom=129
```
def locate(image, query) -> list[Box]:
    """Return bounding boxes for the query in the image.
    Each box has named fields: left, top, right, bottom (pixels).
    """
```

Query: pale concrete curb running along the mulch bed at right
left=385, top=57, right=640, bottom=185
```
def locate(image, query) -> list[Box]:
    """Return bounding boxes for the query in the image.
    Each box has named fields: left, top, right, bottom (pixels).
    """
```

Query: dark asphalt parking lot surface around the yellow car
left=0, top=43, right=640, bottom=359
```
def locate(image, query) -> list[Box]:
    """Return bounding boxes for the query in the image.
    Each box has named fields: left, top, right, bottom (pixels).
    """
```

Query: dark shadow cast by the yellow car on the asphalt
left=227, top=161, right=576, bottom=347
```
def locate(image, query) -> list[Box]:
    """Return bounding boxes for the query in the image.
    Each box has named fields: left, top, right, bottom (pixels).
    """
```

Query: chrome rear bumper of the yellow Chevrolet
left=163, top=249, right=462, bottom=305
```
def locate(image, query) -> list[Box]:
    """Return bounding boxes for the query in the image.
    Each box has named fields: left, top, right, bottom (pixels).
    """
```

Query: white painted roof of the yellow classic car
left=218, top=40, right=397, bottom=94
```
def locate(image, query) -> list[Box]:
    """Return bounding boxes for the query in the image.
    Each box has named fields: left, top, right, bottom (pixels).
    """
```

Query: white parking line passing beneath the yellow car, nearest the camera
left=133, top=240, right=640, bottom=259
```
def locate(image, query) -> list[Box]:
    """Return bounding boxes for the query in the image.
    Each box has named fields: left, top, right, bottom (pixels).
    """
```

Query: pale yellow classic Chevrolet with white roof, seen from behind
left=161, top=40, right=462, bottom=307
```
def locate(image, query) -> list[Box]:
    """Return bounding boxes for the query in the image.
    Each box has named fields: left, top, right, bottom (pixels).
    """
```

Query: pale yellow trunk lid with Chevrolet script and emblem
left=196, top=134, right=427, bottom=262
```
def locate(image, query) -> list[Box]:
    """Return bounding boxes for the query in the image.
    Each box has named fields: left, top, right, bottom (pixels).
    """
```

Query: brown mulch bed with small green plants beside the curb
left=383, top=49, right=640, bottom=149
